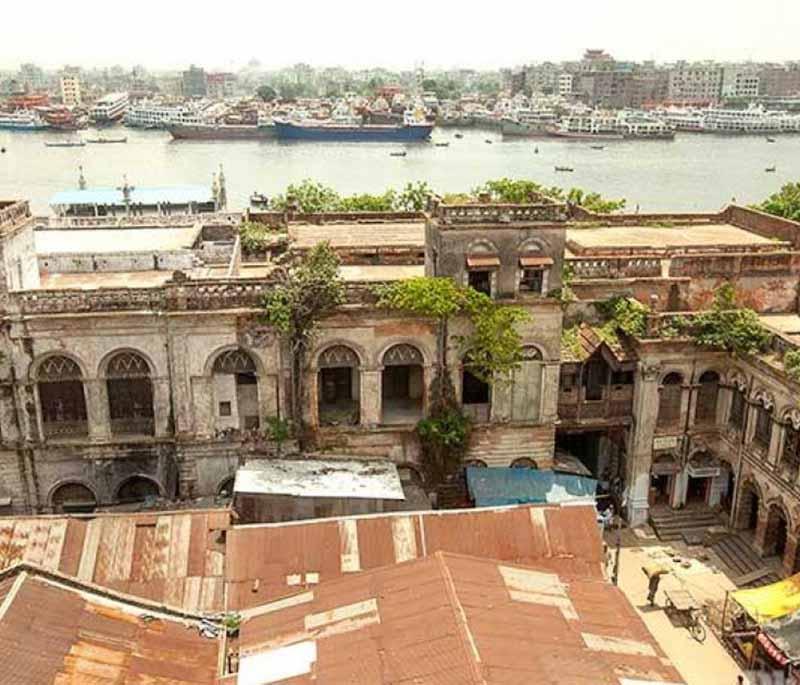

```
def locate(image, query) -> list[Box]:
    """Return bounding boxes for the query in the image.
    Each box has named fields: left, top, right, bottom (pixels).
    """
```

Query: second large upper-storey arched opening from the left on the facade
left=106, top=351, right=155, bottom=435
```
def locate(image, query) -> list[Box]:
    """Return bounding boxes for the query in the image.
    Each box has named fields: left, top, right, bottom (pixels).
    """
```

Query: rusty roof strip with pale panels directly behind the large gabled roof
left=225, top=506, right=603, bottom=609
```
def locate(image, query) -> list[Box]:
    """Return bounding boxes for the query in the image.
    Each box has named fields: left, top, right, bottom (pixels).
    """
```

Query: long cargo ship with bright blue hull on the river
left=275, top=115, right=433, bottom=143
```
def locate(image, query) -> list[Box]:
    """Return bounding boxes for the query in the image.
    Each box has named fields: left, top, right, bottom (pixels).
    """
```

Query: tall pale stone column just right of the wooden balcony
left=625, top=362, right=660, bottom=526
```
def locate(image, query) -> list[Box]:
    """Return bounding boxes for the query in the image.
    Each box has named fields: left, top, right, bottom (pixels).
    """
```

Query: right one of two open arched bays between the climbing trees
left=381, top=345, right=425, bottom=425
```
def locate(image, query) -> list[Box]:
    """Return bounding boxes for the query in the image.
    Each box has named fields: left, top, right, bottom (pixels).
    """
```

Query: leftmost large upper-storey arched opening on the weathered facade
left=36, top=355, right=89, bottom=438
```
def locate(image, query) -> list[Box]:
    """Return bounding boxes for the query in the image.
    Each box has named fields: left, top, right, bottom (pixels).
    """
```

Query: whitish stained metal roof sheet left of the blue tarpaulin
left=233, top=459, right=405, bottom=500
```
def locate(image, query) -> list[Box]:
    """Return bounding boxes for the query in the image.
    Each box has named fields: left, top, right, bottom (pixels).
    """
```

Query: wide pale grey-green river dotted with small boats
left=0, top=128, right=800, bottom=213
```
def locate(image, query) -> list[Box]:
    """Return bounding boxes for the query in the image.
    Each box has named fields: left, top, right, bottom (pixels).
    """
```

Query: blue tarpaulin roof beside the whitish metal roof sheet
left=467, top=466, right=597, bottom=507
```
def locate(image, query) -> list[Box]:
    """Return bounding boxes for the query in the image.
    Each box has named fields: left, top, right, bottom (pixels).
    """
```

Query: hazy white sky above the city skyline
left=0, top=0, right=800, bottom=68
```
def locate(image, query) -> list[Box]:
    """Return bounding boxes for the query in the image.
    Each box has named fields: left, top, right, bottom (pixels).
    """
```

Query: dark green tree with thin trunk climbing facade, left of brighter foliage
left=262, top=243, right=345, bottom=439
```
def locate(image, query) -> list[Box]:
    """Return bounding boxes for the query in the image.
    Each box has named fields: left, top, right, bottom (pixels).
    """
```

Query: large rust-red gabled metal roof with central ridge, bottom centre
left=238, top=552, right=683, bottom=685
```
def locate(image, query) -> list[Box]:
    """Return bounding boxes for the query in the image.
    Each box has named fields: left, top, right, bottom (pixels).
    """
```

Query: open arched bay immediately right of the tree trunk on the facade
left=317, top=345, right=361, bottom=426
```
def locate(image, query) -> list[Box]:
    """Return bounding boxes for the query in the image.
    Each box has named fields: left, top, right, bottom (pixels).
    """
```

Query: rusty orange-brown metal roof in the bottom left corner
left=0, top=571, right=219, bottom=685
